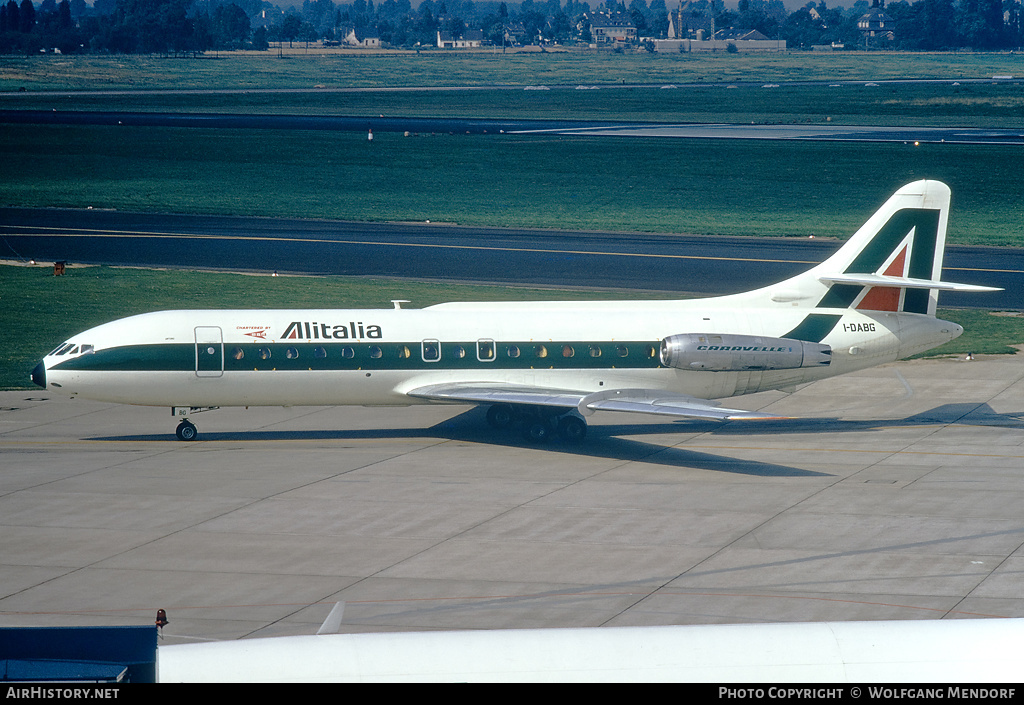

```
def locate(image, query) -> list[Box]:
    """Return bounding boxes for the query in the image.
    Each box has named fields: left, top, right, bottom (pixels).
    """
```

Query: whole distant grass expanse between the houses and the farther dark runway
left=6, top=53, right=1024, bottom=128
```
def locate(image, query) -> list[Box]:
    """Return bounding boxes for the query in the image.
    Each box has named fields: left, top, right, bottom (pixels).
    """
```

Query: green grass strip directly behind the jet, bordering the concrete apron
left=0, top=264, right=1024, bottom=388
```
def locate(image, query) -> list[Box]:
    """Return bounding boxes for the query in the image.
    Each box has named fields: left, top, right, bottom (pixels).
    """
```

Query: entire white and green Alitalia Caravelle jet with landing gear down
left=32, top=180, right=998, bottom=442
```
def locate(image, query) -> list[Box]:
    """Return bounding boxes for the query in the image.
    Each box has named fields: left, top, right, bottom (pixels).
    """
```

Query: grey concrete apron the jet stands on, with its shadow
left=0, top=357, right=1024, bottom=645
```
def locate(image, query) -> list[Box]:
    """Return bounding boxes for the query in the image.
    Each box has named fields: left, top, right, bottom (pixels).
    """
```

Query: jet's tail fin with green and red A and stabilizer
left=805, top=180, right=998, bottom=316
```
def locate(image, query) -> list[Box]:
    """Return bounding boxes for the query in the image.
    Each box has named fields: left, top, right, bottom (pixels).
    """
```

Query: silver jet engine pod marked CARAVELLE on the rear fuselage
left=662, top=333, right=831, bottom=372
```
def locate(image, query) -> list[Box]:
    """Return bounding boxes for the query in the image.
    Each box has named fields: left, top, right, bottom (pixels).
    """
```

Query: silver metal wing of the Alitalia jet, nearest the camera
left=407, top=382, right=785, bottom=421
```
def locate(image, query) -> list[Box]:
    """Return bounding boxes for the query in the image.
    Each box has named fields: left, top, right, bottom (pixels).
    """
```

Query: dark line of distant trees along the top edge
left=0, top=0, right=1024, bottom=54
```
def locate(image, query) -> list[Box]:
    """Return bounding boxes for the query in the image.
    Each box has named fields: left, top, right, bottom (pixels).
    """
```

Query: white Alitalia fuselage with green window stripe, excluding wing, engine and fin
left=44, top=295, right=961, bottom=407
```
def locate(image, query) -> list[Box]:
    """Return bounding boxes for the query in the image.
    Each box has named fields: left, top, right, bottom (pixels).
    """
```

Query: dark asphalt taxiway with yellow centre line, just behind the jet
left=0, top=208, right=1024, bottom=309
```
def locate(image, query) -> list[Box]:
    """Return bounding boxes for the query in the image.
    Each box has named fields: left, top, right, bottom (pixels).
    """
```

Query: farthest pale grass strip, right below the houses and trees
left=6, top=52, right=1024, bottom=92
